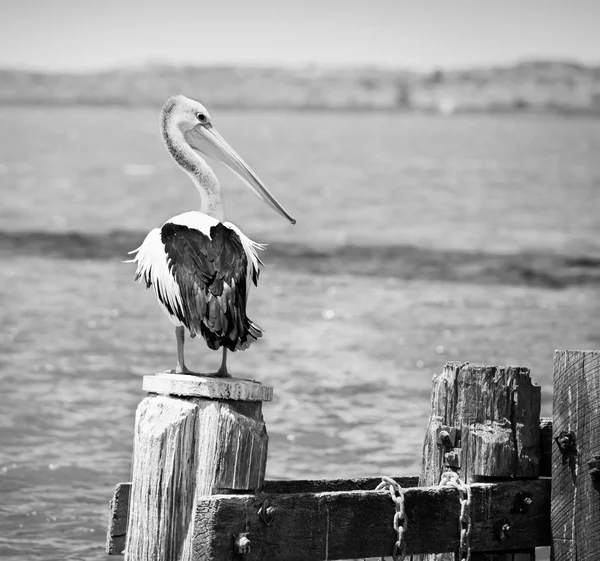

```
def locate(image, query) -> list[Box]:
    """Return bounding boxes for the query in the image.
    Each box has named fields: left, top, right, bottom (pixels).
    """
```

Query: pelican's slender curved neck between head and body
left=163, top=123, right=223, bottom=221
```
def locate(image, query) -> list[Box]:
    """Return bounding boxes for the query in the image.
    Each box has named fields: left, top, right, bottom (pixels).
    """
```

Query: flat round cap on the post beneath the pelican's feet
left=142, top=372, right=273, bottom=401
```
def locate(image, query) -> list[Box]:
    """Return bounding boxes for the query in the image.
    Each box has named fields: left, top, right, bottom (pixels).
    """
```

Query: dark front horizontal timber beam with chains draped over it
left=193, top=480, right=550, bottom=561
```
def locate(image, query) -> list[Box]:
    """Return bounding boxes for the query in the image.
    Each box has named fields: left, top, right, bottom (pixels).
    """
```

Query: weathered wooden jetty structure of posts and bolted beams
left=107, top=351, right=600, bottom=561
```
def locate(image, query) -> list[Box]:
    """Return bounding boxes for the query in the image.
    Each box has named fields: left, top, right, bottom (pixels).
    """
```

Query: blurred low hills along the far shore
left=0, top=60, right=600, bottom=114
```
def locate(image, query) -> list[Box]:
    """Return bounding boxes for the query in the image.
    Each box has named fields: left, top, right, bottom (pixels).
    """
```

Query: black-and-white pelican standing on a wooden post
left=130, top=95, right=296, bottom=376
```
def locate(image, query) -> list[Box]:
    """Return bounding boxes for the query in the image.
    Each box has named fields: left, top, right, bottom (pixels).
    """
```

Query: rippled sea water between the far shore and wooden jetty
left=0, top=106, right=600, bottom=561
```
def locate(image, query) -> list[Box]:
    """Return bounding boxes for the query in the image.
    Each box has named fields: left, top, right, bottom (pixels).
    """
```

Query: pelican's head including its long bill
left=161, top=95, right=296, bottom=224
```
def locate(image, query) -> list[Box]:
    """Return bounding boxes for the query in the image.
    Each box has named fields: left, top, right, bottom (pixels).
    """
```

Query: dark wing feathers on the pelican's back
left=161, top=222, right=262, bottom=351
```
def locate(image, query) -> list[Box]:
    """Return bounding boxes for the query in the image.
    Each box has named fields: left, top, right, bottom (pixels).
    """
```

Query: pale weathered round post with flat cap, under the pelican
left=125, top=374, right=272, bottom=561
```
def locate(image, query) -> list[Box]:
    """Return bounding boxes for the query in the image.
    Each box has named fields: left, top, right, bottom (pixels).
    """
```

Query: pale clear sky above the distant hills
left=0, top=0, right=600, bottom=72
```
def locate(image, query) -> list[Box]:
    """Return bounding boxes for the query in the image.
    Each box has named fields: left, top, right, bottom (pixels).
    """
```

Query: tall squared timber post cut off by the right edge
left=551, top=351, right=600, bottom=561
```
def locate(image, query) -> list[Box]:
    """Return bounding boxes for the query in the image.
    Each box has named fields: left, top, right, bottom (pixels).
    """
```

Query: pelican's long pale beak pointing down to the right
left=185, top=124, right=296, bottom=224
